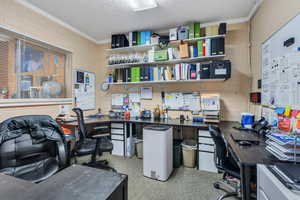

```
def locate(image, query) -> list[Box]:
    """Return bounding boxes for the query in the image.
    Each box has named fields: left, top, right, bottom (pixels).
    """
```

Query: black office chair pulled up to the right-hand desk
left=209, top=125, right=241, bottom=200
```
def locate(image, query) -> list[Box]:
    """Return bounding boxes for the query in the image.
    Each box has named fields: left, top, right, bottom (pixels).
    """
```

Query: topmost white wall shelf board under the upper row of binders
left=106, top=35, right=225, bottom=53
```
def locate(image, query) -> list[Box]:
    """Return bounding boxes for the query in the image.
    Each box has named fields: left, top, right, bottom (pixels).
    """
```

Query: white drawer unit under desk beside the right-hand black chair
left=198, top=130, right=218, bottom=173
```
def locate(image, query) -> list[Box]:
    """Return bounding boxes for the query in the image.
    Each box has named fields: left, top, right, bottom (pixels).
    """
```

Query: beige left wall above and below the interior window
left=0, top=0, right=101, bottom=121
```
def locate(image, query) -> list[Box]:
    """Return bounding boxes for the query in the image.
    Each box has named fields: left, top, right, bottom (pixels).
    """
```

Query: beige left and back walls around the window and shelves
left=0, top=0, right=251, bottom=121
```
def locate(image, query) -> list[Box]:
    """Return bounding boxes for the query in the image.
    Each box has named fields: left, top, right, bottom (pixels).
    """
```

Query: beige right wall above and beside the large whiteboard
left=250, top=0, right=300, bottom=116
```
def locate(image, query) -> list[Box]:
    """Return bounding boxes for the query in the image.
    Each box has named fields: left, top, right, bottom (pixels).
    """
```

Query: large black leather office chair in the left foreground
left=0, top=115, right=66, bottom=183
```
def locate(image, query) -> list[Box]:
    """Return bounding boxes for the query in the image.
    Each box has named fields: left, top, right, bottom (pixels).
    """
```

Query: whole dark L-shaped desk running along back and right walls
left=61, top=117, right=278, bottom=200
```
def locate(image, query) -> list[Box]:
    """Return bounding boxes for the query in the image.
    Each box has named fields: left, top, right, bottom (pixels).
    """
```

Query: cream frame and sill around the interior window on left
left=0, top=26, right=73, bottom=108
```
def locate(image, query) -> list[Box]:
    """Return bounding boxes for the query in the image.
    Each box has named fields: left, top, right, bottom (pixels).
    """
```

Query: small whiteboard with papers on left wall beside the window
left=74, top=70, right=96, bottom=110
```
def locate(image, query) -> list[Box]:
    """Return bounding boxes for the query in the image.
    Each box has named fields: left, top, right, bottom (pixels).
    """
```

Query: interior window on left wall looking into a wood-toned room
left=0, top=31, right=71, bottom=100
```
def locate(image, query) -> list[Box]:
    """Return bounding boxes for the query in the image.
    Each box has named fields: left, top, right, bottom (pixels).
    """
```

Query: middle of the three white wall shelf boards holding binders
left=108, top=55, right=225, bottom=69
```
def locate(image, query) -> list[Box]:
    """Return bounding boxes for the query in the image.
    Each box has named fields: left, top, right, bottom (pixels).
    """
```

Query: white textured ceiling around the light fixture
left=18, top=0, right=257, bottom=42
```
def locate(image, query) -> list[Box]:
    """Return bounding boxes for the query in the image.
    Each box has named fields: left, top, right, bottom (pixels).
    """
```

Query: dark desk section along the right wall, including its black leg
left=219, top=122, right=279, bottom=200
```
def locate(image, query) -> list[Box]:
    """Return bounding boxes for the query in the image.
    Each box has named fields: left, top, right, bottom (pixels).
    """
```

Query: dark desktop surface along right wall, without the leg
left=219, top=122, right=279, bottom=165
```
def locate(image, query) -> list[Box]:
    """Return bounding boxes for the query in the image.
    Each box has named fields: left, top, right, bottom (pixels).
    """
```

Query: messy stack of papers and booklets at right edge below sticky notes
left=266, top=131, right=300, bottom=162
